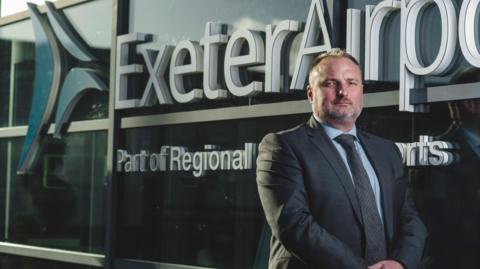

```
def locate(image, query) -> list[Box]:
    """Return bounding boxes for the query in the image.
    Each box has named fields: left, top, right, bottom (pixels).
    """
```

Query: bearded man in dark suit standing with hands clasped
left=257, top=49, right=426, bottom=269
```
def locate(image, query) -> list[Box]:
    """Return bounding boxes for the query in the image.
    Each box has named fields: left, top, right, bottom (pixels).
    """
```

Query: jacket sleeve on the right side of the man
left=390, top=143, right=427, bottom=269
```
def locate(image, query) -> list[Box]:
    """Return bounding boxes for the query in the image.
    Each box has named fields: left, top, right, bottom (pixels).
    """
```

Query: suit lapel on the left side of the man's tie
left=307, top=116, right=363, bottom=225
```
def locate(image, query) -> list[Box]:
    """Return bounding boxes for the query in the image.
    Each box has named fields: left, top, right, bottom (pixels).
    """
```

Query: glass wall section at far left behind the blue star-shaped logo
left=0, top=0, right=112, bottom=264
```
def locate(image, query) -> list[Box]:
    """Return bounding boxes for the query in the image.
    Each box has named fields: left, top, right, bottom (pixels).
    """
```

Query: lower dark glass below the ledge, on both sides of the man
left=117, top=92, right=480, bottom=269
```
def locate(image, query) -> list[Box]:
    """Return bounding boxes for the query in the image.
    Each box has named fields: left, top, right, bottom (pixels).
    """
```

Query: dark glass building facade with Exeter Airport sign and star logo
left=0, top=0, right=480, bottom=269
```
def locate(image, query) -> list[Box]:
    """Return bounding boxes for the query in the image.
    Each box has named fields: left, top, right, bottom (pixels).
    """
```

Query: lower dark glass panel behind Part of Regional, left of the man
left=117, top=115, right=308, bottom=268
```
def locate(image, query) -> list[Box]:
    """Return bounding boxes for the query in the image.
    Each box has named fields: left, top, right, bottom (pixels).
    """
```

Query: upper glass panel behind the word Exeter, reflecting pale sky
left=122, top=0, right=311, bottom=114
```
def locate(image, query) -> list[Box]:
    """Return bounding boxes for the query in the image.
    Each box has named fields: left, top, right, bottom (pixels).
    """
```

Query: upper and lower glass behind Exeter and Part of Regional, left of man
left=117, top=0, right=310, bottom=268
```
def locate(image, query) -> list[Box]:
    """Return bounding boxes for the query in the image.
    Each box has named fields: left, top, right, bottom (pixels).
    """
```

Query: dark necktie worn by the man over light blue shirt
left=335, top=134, right=387, bottom=265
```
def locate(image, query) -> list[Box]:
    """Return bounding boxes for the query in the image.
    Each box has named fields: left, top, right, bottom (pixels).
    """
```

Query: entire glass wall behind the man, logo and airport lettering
left=0, top=0, right=480, bottom=269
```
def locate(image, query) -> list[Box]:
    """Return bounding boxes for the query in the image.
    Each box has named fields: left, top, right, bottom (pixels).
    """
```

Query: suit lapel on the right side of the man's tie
left=357, top=131, right=394, bottom=240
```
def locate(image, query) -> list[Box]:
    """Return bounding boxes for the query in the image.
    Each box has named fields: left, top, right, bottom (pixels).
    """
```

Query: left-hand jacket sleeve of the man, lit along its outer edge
left=257, top=134, right=367, bottom=268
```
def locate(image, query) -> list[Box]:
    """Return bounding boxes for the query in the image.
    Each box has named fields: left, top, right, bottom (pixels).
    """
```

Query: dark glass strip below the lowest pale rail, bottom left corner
left=0, top=254, right=98, bottom=269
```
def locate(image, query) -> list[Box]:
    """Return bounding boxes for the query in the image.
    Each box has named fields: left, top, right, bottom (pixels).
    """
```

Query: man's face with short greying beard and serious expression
left=307, top=57, right=363, bottom=129
